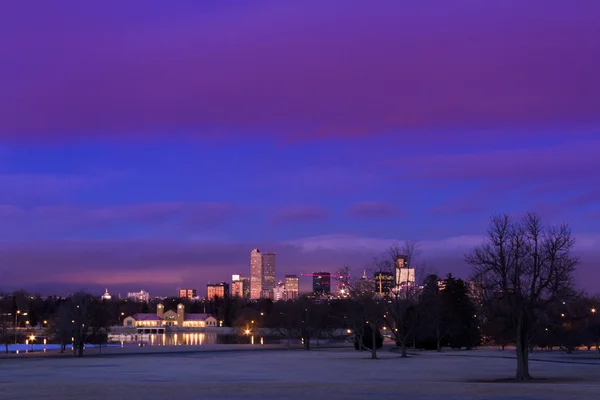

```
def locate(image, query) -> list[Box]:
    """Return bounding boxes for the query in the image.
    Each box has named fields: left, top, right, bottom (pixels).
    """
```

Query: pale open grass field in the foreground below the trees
left=0, top=345, right=600, bottom=400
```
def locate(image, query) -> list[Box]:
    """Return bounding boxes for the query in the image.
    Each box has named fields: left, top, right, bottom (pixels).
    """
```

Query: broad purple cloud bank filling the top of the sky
left=0, top=0, right=600, bottom=143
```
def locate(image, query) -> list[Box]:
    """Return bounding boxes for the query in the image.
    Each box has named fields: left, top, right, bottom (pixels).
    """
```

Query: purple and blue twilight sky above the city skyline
left=0, top=0, right=600, bottom=295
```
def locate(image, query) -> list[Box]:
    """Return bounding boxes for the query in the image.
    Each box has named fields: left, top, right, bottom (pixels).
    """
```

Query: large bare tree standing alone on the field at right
left=465, top=213, right=578, bottom=381
